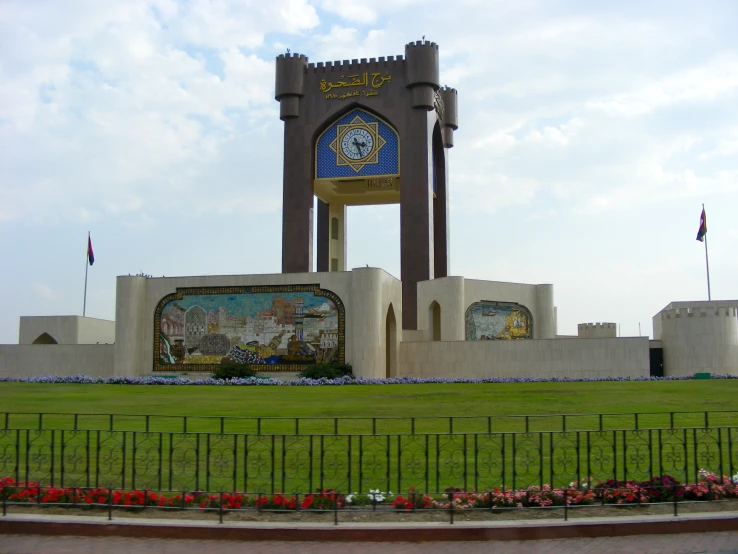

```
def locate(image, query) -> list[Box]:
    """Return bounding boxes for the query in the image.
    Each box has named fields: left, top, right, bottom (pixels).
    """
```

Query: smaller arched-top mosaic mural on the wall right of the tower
left=465, top=300, right=533, bottom=340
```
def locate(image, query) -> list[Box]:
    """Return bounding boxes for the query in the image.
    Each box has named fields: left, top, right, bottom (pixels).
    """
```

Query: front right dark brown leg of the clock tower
left=400, top=109, right=433, bottom=329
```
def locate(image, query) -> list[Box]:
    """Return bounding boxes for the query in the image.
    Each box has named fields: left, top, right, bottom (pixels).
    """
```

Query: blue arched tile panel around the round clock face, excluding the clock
left=315, top=108, right=400, bottom=179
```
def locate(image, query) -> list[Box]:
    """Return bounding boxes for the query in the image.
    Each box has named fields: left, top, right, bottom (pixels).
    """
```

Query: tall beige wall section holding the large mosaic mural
left=115, top=268, right=402, bottom=377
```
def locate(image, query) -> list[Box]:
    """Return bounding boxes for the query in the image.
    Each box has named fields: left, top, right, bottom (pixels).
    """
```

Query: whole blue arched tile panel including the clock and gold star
left=315, top=108, right=400, bottom=179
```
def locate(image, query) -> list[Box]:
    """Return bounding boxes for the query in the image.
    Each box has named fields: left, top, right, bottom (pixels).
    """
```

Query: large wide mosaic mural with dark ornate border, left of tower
left=154, top=285, right=345, bottom=371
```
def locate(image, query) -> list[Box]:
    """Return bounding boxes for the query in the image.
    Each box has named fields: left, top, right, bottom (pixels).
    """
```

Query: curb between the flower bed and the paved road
left=0, top=513, right=738, bottom=542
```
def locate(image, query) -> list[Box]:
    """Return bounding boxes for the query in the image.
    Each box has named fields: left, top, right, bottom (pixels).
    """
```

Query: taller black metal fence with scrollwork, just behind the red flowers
left=0, top=426, right=738, bottom=492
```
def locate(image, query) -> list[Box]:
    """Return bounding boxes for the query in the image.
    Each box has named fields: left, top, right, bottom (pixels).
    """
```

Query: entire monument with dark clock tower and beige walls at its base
left=0, top=41, right=738, bottom=378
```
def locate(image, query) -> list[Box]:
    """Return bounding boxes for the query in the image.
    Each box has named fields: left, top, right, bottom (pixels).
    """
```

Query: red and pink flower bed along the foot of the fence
left=0, top=471, right=738, bottom=512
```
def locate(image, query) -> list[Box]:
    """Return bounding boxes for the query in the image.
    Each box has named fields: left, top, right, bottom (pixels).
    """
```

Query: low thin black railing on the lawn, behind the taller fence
left=0, top=410, right=738, bottom=435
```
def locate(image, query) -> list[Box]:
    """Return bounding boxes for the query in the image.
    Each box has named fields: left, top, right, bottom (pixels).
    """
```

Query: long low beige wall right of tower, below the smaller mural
left=398, top=337, right=649, bottom=378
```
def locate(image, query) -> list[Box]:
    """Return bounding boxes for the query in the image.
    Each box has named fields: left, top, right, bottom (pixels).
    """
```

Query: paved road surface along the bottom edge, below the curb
left=0, top=531, right=738, bottom=554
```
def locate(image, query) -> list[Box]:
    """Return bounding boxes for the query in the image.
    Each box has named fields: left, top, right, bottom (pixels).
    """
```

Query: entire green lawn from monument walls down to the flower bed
left=0, top=380, right=738, bottom=492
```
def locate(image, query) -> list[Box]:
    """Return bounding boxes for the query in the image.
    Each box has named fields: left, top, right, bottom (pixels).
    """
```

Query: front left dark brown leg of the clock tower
left=282, top=118, right=313, bottom=273
